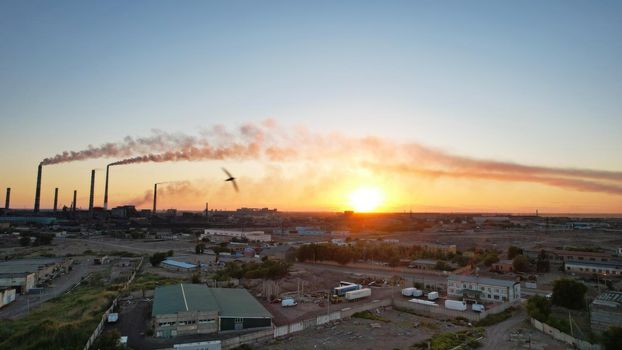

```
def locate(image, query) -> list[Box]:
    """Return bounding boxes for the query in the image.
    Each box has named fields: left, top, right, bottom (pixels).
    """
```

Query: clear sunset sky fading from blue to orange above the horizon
left=0, top=1, right=622, bottom=213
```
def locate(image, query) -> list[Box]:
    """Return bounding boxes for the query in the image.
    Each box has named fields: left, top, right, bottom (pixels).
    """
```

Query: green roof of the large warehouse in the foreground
left=151, top=283, right=272, bottom=318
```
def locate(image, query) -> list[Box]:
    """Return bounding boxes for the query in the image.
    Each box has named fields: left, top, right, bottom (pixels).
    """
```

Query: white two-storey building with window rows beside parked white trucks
left=447, top=275, right=521, bottom=302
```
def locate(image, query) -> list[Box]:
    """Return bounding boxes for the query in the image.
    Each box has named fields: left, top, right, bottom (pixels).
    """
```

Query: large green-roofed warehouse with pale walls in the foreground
left=151, top=284, right=272, bottom=338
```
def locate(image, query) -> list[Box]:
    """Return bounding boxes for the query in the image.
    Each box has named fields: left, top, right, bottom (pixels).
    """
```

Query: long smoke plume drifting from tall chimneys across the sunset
left=43, top=120, right=622, bottom=196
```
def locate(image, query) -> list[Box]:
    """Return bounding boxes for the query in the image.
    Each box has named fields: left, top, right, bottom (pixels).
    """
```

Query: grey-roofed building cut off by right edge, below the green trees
left=590, top=291, right=622, bottom=332
